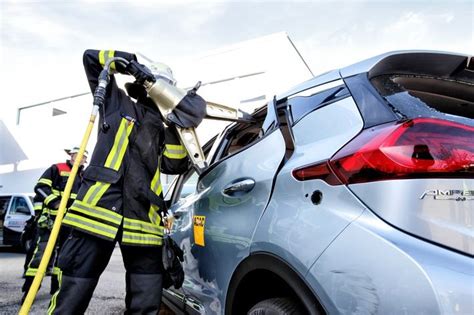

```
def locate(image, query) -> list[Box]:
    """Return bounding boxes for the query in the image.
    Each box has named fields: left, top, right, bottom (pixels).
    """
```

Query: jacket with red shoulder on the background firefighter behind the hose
left=33, top=161, right=82, bottom=228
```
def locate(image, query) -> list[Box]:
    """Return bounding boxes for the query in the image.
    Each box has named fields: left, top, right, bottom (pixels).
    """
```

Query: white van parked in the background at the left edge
left=0, top=194, right=34, bottom=250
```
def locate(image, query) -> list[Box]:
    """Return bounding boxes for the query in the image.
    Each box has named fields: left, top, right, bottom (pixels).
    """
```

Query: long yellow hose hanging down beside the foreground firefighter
left=19, top=106, right=98, bottom=315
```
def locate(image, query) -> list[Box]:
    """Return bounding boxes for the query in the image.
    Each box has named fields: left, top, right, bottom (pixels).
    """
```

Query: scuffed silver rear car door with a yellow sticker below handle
left=165, top=105, right=286, bottom=313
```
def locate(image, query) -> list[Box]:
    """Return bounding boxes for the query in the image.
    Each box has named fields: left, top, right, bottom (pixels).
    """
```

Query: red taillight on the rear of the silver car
left=293, top=118, right=474, bottom=185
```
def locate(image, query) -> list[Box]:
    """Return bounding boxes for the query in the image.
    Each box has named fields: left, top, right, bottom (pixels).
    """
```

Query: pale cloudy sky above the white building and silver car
left=0, top=0, right=474, bottom=122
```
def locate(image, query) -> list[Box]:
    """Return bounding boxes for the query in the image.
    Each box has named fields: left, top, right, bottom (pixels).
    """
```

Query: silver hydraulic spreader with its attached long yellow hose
left=19, top=57, right=254, bottom=315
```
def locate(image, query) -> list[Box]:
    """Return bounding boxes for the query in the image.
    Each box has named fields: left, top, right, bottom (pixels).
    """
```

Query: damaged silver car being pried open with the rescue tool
left=164, top=51, right=474, bottom=315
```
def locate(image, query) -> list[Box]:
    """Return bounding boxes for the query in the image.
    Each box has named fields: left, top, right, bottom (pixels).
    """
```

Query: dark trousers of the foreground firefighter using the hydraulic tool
left=48, top=230, right=163, bottom=314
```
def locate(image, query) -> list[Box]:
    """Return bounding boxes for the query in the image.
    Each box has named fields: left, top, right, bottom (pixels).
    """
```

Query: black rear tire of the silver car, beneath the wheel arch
left=247, top=298, right=307, bottom=315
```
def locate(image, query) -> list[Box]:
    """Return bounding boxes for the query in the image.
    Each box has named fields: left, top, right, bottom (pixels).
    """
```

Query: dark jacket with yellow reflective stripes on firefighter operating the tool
left=63, top=50, right=188, bottom=246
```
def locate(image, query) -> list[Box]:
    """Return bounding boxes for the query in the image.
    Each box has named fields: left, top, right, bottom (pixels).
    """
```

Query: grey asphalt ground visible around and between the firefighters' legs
left=0, top=247, right=125, bottom=314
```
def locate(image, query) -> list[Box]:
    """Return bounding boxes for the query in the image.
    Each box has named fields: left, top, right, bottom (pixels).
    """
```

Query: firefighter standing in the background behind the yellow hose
left=22, top=147, right=87, bottom=301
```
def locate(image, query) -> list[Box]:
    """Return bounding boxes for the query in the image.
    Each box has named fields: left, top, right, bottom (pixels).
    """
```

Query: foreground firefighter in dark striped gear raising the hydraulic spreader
left=48, top=50, right=206, bottom=314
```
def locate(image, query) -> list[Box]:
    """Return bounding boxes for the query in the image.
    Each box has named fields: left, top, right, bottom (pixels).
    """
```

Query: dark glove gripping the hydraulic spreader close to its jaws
left=167, top=93, right=207, bottom=128
